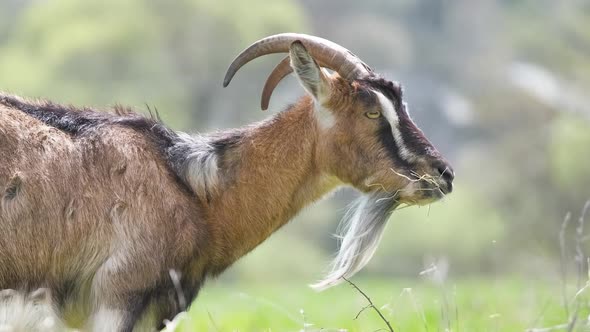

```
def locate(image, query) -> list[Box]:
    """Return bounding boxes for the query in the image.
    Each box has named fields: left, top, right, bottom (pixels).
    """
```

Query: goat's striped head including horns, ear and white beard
left=224, top=33, right=454, bottom=289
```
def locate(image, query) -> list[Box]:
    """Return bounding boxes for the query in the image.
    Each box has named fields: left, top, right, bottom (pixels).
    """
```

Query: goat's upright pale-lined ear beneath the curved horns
left=289, top=40, right=330, bottom=102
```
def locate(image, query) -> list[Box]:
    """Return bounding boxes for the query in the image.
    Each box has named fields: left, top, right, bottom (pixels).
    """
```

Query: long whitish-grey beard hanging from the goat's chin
left=311, top=192, right=399, bottom=290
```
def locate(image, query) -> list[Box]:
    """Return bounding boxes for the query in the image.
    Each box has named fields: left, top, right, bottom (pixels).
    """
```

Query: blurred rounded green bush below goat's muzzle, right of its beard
left=369, top=182, right=506, bottom=274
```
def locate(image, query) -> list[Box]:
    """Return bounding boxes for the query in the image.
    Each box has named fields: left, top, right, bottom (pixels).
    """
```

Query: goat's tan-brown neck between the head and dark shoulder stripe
left=208, top=97, right=338, bottom=271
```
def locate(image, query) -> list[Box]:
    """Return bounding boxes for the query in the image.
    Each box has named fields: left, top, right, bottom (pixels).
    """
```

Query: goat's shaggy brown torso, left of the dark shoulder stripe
left=0, top=101, right=208, bottom=330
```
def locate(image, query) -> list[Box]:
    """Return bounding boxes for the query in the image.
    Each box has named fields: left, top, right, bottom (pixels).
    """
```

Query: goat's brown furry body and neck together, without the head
left=0, top=93, right=337, bottom=330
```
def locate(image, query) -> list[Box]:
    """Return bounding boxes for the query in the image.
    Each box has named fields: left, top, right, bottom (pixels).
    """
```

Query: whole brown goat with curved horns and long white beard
left=0, top=33, right=454, bottom=331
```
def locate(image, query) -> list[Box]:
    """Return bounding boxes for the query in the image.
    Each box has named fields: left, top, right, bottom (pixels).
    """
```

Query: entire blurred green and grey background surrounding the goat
left=0, top=0, right=590, bottom=331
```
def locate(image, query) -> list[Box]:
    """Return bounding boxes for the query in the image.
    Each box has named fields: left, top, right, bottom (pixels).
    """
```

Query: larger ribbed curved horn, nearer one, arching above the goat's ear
left=223, top=33, right=372, bottom=87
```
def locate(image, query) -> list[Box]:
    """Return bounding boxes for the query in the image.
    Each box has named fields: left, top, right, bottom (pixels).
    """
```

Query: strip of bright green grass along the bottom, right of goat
left=172, top=279, right=589, bottom=332
